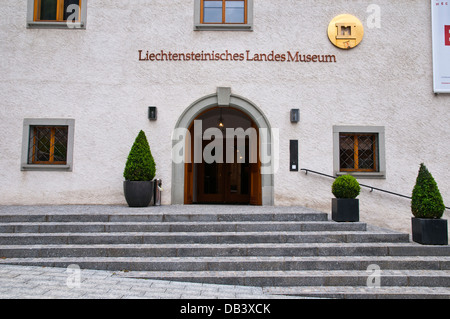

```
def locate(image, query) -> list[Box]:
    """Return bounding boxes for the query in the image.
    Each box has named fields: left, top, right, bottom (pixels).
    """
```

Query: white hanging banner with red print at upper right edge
left=431, top=0, right=450, bottom=93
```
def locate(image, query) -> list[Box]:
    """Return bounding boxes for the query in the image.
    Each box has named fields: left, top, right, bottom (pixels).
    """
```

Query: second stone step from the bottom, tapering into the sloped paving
left=111, top=270, right=450, bottom=294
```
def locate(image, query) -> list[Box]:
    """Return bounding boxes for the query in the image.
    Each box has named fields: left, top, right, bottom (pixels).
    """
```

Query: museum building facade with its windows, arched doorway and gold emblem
left=0, top=0, right=450, bottom=235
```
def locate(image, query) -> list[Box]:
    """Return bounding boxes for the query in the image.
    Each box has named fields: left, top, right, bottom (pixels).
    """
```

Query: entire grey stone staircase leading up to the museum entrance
left=0, top=205, right=450, bottom=299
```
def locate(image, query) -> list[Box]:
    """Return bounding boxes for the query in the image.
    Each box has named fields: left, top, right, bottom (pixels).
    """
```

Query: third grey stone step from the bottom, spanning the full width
left=1, top=256, right=450, bottom=277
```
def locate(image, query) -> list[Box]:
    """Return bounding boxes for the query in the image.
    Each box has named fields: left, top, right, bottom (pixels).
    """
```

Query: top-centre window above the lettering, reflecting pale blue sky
left=194, top=0, right=253, bottom=31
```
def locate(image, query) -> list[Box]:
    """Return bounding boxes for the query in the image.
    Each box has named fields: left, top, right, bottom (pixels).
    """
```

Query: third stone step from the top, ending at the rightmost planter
left=0, top=231, right=409, bottom=245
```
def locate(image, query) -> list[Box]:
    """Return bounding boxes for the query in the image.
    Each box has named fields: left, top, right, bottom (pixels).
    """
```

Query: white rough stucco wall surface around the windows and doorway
left=0, top=0, right=450, bottom=235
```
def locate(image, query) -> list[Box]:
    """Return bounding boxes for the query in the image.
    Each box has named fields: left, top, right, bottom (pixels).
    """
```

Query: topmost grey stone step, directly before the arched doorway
left=0, top=210, right=328, bottom=223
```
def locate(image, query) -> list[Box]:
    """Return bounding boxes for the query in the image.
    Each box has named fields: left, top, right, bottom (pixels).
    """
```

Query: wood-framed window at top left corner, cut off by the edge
left=27, top=0, right=87, bottom=29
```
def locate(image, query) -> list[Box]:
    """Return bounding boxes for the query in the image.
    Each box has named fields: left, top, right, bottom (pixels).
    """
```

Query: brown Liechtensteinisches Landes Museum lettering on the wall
left=138, top=50, right=337, bottom=63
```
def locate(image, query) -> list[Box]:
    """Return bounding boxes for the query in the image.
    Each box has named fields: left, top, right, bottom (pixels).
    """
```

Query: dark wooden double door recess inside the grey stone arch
left=184, top=107, right=262, bottom=205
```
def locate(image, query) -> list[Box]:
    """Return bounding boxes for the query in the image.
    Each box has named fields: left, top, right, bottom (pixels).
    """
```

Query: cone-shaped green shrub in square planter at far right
left=411, top=163, right=445, bottom=218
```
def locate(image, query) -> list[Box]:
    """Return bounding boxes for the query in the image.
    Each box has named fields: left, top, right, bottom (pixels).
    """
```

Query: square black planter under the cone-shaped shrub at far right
left=411, top=217, right=448, bottom=245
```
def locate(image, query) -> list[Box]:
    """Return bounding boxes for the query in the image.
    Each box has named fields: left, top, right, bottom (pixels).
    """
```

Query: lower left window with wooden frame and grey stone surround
left=22, top=119, right=74, bottom=171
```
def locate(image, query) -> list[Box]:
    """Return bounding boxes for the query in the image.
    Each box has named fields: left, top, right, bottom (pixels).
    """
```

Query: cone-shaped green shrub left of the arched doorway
left=123, top=130, right=156, bottom=181
